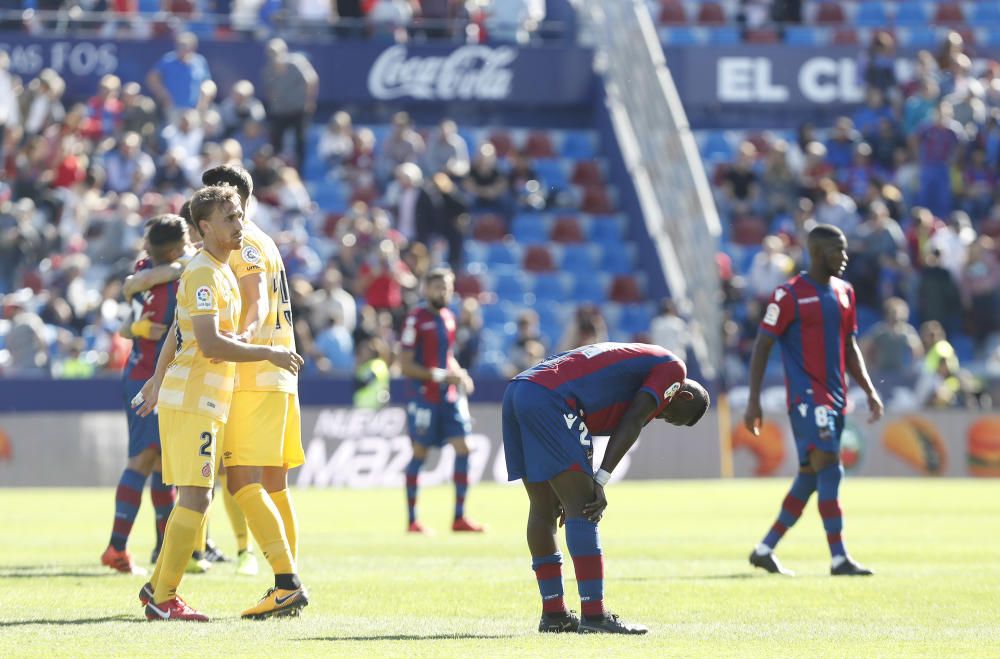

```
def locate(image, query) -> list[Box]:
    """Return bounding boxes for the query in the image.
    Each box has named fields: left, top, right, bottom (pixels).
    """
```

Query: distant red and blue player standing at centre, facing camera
left=399, top=268, right=483, bottom=533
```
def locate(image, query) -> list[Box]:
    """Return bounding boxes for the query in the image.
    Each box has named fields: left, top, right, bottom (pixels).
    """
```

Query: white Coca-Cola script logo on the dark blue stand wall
left=368, top=45, right=517, bottom=101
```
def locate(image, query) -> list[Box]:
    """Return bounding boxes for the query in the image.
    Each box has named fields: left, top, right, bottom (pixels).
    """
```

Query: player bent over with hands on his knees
left=503, top=343, right=709, bottom=634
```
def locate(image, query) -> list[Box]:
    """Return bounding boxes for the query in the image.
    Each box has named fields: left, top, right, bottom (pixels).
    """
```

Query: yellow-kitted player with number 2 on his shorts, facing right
left=135, top=186, right=308, bottom=621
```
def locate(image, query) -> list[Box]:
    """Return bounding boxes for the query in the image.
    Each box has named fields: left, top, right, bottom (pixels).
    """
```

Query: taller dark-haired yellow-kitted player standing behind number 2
left=201, top=165, right=305, bottom=618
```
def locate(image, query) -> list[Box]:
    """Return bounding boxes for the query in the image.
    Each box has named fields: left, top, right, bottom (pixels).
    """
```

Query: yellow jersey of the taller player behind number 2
left=229, top=222, right=299, bottom=394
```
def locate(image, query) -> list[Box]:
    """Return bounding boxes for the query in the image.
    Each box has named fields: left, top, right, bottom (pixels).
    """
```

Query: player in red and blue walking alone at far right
left=743, top=224, right=883, bottom=576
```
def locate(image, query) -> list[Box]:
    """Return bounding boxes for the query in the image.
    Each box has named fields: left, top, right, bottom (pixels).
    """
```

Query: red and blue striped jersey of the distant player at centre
left=400, top=307, right=458, bottom=403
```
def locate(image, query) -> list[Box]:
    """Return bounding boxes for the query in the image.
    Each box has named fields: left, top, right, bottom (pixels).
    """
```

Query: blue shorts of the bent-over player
left=503, top=380, right=594, bottom=483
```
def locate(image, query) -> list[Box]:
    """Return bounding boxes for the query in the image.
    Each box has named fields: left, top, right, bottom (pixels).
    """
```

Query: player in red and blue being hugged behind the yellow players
left=101, top=215, right=191, bottom=574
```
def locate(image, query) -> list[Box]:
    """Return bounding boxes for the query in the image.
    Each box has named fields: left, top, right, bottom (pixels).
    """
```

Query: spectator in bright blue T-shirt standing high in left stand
left=146, top=32, right=212, bottom=123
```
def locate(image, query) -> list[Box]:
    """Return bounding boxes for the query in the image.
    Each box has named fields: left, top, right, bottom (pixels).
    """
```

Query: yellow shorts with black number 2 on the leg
left=159, top=408, right=223, bottom=488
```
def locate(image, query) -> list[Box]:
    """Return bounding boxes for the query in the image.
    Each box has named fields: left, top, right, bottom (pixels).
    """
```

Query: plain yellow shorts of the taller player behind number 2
left=222, top=391, right=306, bottom=469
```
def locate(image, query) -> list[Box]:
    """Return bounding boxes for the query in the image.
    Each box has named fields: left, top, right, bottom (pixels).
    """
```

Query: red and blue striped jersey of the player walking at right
left=760, top=272, right=858, bottom=412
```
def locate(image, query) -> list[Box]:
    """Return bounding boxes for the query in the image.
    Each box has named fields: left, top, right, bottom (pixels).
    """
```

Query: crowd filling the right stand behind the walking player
left=714, top=32, right=1000, bottom=405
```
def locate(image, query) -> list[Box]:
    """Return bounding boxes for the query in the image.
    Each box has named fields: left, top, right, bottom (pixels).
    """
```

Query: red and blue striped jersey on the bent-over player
left=514, top=343, right=687, bottom=435
